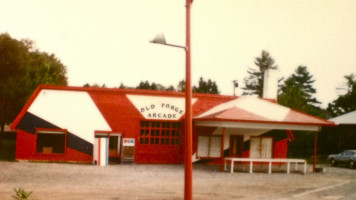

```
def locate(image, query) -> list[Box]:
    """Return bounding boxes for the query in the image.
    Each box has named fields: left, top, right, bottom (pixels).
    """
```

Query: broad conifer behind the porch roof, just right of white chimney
left=278, top=66, right=321, bottom=115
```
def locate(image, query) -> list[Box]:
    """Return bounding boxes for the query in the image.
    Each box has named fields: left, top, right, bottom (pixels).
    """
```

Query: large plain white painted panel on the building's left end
left=28, top=89, right=110, bottom=143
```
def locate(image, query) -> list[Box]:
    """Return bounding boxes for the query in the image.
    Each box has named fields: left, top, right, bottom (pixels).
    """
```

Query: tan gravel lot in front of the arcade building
left=0, top=162, right=356, bottom=200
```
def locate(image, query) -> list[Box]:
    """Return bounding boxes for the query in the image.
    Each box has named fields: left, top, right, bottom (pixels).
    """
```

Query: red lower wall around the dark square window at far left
left=16, top=130, right=93, bottom=163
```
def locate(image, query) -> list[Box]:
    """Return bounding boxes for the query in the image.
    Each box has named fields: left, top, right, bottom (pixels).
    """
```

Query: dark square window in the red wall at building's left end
left=37, top=130, right=67, bottom=154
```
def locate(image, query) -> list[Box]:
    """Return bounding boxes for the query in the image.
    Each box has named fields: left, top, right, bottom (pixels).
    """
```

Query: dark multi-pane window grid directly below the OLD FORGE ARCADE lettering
left=140, top=121, right=182, bottom=145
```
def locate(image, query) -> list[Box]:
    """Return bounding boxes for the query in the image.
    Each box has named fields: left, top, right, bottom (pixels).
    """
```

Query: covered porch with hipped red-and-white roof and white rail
left=194, top=97, right=334, bottom=173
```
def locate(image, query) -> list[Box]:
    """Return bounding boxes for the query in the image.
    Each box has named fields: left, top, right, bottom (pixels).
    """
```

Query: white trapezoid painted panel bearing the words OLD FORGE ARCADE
left=127, top=95, right=196, bottom=120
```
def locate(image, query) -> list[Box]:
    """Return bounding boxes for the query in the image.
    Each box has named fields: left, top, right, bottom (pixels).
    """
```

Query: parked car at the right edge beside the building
left=328, top=150, right=356, bottom=168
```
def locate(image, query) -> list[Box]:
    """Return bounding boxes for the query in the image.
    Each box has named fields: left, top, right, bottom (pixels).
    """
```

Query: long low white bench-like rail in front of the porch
left=224, top=157, right=307, bottom=174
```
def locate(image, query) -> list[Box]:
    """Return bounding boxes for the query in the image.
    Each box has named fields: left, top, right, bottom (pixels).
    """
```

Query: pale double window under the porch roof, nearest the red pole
left=197, top=135, right=221, bottom=158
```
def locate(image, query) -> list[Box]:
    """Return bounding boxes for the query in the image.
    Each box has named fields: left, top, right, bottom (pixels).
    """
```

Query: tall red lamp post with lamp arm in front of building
left=151, top=0, right=193, bottom=200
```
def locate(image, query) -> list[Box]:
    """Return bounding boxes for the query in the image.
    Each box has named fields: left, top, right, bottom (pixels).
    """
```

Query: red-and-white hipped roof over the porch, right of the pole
left=194, top=96, right=335, bottom=126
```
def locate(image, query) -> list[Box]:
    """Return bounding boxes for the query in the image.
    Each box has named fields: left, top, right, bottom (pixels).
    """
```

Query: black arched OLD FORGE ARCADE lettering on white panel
left=140, top=103, right=184, bottom=119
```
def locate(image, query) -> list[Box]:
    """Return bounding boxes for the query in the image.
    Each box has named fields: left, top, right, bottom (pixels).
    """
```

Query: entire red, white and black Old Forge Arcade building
left=11, top=85, right=334, bottom=165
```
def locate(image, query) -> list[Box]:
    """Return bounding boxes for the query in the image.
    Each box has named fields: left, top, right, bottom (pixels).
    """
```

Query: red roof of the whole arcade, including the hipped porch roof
left=11, top=85, right=334, bottom=130
